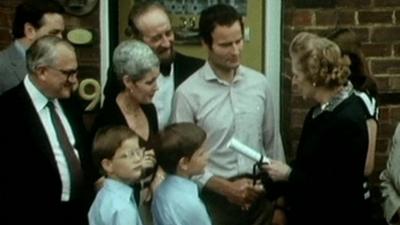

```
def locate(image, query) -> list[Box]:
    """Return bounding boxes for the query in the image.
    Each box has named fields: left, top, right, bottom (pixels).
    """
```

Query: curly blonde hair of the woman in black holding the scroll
left=289, top=32, right=350, bottom=89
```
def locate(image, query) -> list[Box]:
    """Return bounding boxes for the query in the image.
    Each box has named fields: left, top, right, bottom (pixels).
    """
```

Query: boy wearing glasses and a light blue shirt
left=88, top=126, right=144, bottom=225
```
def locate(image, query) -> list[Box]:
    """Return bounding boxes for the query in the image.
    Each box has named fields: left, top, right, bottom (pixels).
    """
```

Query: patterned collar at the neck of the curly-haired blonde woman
left=313, top=82, right=354, bottom=118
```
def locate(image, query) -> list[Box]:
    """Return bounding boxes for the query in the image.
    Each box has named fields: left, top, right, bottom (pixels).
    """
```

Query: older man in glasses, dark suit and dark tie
left=0, top=36, right=93, bottom=224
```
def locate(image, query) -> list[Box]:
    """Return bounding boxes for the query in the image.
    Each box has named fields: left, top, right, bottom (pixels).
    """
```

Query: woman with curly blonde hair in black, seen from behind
left=264, top=32, right=372, bottom=225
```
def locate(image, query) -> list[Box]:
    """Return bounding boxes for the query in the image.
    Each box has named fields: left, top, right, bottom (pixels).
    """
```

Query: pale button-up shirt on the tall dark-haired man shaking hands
left=173, top=62, right=285, bottom=185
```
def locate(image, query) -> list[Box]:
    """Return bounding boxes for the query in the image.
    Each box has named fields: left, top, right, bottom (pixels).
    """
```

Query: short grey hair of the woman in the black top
left=113, top=40, right=160, bottom=81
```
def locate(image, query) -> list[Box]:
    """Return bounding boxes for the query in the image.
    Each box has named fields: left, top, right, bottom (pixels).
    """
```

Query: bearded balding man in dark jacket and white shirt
left=104, top=1, right=204, bottom=129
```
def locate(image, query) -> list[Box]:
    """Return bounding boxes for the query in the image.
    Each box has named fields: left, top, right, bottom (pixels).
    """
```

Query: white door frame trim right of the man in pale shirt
left=264, top=0, right=282, bottom=127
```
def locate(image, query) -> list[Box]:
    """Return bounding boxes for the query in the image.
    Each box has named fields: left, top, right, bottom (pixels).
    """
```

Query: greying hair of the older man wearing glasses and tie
left=26, top=35, right=75, bottom=74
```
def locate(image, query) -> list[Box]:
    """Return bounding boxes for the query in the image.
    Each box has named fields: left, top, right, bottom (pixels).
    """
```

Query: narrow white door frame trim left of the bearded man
left=99, top=1, right=110, bottom=105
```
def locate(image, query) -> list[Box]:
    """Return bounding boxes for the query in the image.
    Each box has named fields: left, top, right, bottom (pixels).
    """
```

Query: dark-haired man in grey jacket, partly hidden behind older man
left=0, top=0, right=64, bottom=94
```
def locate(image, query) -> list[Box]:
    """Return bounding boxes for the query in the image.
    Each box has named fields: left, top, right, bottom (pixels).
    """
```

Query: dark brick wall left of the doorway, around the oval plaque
left=0, top=0, right=100, bottom=127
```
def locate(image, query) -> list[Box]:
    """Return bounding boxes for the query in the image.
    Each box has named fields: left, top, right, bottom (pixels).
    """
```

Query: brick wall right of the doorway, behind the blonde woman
left=282, top=0, right=400, bottom=181
